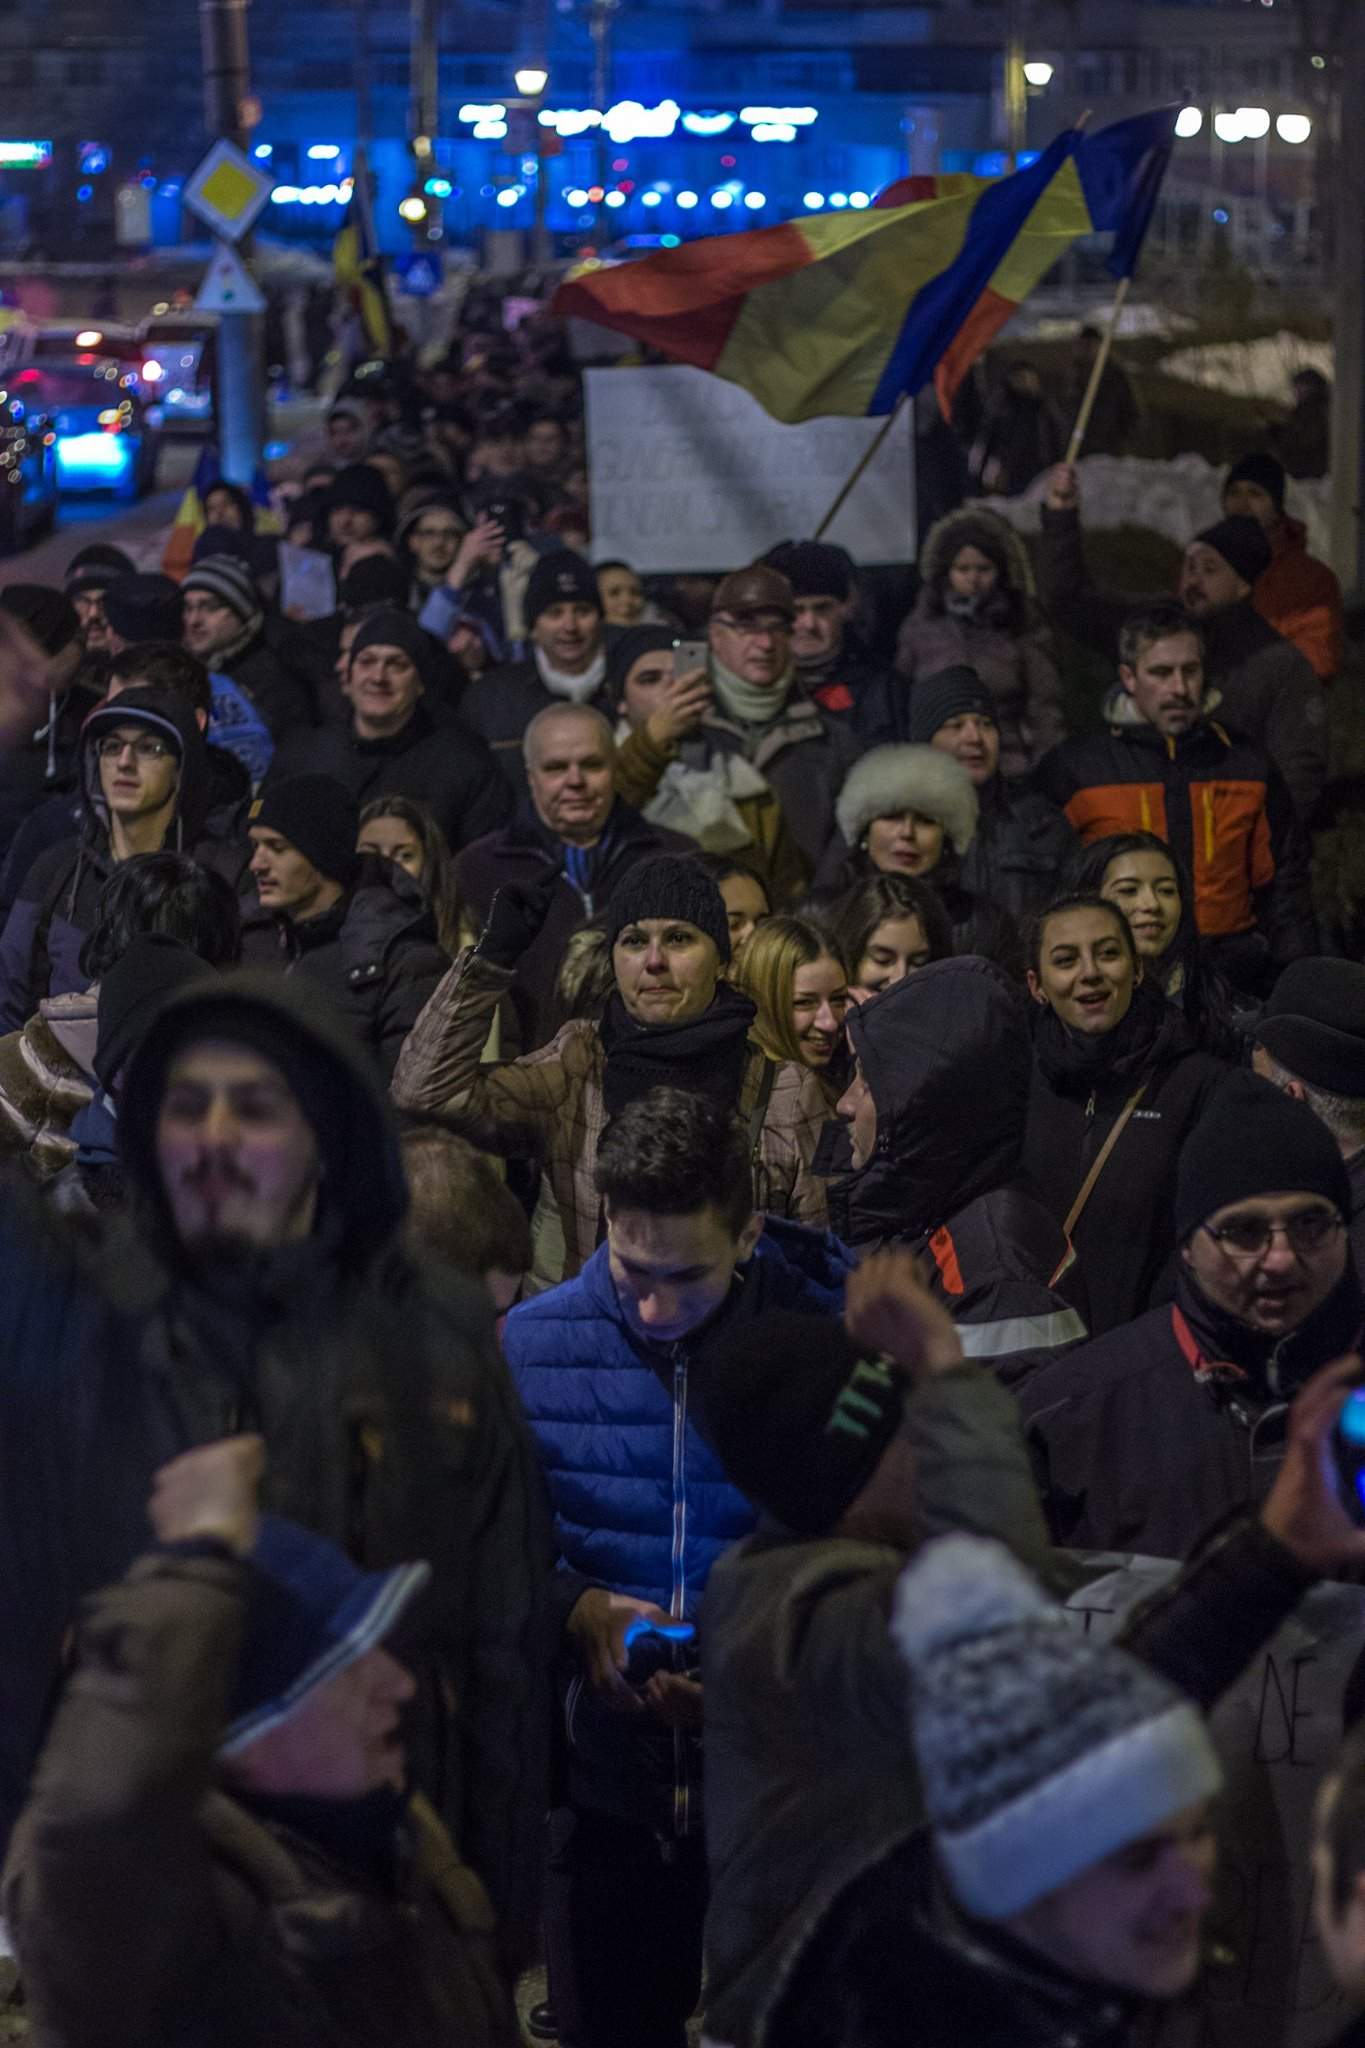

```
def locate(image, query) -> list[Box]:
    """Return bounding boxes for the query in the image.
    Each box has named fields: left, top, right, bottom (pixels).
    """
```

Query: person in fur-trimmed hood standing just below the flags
left=896, top=510, right=1066, bottom=776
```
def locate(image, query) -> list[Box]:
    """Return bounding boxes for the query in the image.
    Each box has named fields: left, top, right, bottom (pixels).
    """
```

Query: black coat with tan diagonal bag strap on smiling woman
left=1023, top=981, right=1228, bottom=1335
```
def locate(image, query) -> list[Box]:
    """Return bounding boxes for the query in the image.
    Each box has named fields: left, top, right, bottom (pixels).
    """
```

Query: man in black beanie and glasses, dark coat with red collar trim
left=1019, top=1073, right=1365, bottom=1556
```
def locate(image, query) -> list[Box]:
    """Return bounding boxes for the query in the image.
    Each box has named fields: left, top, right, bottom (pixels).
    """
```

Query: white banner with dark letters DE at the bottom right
left=1068, top=1559, right=1365, bottom=2048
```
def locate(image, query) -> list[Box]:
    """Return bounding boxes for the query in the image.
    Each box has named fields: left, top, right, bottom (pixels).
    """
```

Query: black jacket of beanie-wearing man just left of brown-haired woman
left=244, top=854, right=450, bottom=1083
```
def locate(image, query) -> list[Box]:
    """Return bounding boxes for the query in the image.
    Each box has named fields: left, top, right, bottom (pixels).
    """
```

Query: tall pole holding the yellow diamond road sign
left=199, top=0, right=266, bottom=487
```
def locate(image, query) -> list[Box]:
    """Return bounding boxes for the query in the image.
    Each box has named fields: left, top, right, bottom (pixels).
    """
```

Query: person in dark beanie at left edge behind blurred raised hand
left=0, top=584, right=98, bottom=858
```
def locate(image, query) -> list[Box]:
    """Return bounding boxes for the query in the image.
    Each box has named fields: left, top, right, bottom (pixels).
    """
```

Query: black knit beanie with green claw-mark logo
left=696, top=1309, right=905, bottom=1536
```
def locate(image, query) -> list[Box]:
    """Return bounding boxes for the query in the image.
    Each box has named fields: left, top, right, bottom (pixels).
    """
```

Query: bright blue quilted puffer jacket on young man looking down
left=503, top=1217, right=853, bottom=1614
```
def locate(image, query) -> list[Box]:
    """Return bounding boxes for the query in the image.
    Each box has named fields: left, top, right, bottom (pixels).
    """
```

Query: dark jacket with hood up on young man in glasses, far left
left=0, top=690, right=252, bottom=1030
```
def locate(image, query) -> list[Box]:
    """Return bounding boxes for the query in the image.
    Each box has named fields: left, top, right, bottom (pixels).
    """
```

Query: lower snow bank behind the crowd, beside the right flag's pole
left=980, top=455, right=1332, bottom=555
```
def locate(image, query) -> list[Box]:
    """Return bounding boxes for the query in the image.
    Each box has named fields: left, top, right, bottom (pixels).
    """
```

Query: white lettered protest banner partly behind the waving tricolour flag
left=583, top=365, right=915, bottom=573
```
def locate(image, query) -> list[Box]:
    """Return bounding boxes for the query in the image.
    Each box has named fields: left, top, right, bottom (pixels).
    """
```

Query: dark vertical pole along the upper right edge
left=1332, top=18, right=1365, bottom=594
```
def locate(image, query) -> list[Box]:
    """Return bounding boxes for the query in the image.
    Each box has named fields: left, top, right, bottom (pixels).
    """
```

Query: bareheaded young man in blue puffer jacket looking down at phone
left=503, top=1087, right=851, bottom=2048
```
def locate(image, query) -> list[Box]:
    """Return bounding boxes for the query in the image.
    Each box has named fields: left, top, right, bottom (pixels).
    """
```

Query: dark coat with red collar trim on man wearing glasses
left=1019, top=1266, right=1365, bottom=1556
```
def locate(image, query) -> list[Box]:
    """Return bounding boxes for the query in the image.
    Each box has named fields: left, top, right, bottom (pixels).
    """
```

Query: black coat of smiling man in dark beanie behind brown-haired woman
left=266, top=705, right=512, bottom=854
